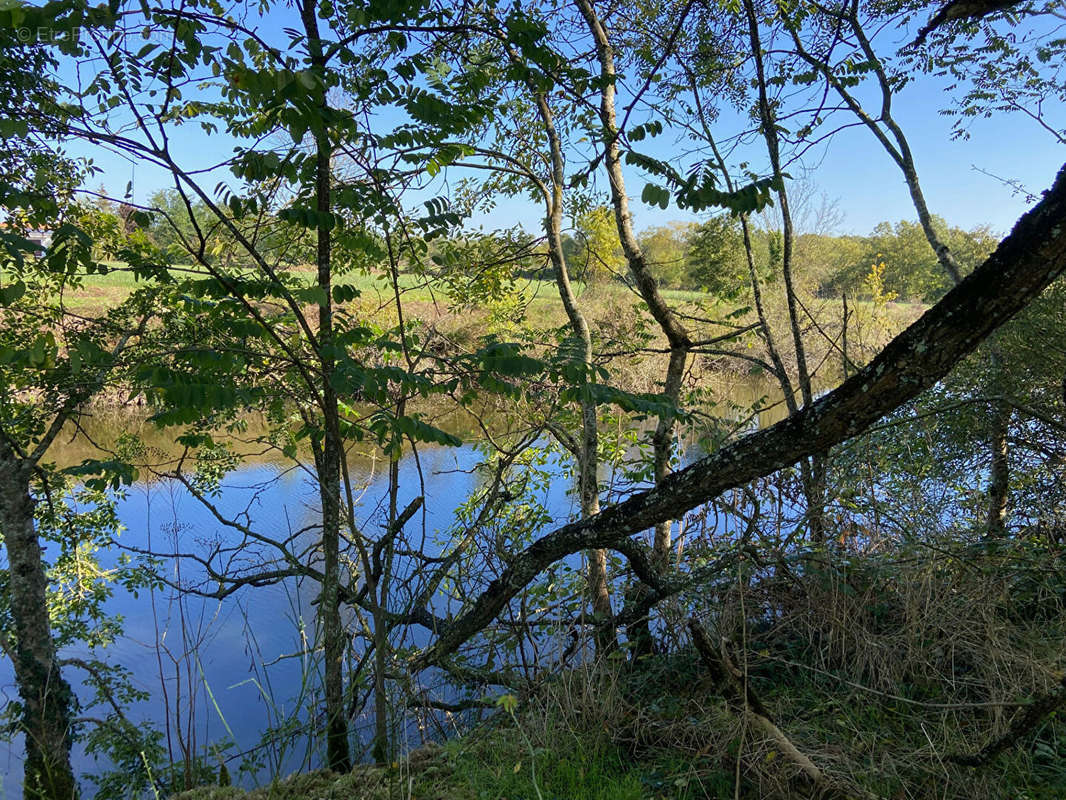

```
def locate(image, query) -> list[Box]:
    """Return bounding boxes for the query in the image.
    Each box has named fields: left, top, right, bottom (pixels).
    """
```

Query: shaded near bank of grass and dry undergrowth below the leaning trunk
left=168, top=540, right=1066, bottom=800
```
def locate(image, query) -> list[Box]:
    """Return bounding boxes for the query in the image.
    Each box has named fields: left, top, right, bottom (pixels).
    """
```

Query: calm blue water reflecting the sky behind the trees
left=0, top=379, right=779, bottom=798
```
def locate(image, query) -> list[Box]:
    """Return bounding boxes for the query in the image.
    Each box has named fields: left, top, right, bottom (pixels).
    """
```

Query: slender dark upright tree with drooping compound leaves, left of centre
left=6, top=2, right=494, bottom=771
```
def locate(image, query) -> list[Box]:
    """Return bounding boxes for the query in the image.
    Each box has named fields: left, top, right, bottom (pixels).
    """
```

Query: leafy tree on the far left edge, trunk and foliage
left=0, top=15, right=162, bottom=800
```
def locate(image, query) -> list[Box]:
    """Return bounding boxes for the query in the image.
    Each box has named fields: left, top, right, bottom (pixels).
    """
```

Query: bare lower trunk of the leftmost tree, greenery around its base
left=0, top=446, right=78, bottom=800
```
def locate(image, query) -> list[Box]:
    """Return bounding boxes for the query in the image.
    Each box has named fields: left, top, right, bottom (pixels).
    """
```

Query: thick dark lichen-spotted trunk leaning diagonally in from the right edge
left=411, top=167, right=1066, bottom=670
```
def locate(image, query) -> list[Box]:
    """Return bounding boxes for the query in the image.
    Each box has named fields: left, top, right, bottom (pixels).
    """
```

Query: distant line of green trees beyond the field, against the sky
left=100, top=192, right=998, bottom=303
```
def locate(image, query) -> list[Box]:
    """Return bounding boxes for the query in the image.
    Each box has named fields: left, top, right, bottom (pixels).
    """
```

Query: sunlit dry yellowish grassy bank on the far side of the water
left=64, top=263, right=924, bottom=391
